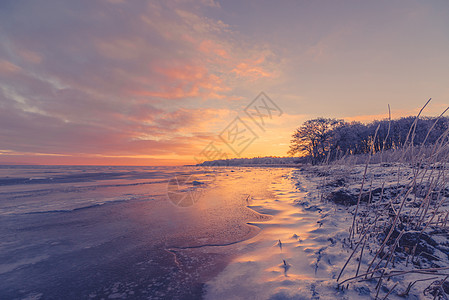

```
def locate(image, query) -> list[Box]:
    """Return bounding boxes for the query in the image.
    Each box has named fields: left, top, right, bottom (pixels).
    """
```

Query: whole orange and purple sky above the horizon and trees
left=0, top=0, right=449, bottom=165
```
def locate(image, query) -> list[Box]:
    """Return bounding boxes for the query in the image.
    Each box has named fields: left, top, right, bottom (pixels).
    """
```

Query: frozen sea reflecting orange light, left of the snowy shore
left=0, top=166, right=291, bottom=299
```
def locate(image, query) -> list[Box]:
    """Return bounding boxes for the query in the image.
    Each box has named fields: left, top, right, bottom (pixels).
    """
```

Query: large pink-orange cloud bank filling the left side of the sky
left=0, top=0, right=282, bottom=164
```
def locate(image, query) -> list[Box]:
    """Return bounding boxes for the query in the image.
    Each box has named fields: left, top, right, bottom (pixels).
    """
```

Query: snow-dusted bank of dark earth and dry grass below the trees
left=307, top=163, right=449, bottom=299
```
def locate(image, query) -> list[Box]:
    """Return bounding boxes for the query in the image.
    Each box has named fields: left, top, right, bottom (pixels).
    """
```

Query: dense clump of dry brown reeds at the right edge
left=337, top=99, right=449, bottom=299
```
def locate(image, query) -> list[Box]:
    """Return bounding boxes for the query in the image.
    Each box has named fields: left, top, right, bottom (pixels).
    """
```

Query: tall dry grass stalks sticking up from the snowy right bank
left=337, top=99, right=449, bottom=299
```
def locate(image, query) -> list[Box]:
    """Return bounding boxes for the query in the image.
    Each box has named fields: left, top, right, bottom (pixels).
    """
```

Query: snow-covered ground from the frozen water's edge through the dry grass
left=206, top=165, right=449, bottom=299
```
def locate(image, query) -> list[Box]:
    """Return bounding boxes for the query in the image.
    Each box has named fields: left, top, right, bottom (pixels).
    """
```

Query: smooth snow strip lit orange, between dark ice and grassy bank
left=206, top=170, right=362, bottom=299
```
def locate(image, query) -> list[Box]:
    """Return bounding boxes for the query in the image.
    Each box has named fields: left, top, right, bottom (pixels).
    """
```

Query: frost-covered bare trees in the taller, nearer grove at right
left=288, top=116, right=449, bottom=163
